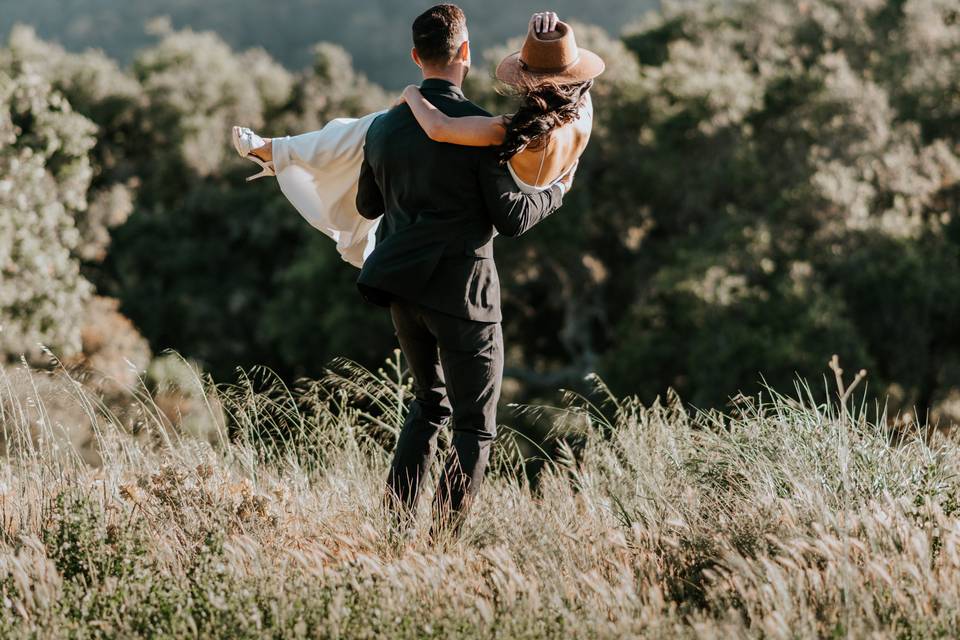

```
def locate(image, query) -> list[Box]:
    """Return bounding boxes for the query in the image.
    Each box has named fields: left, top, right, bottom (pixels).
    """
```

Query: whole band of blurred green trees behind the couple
left=0, top=0, right=960, bottom=420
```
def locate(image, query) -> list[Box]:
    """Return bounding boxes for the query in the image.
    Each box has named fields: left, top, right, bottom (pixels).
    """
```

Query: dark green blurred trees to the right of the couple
left=462, top=0, right=960, bottom=419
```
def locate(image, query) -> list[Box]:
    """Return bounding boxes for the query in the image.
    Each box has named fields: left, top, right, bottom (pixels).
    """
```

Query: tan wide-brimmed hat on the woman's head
left=497, top=22, right=605, bottom=86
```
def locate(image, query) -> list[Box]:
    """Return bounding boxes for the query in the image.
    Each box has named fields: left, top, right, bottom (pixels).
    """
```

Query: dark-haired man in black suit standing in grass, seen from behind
left=357, top=4, right=567, bottom=531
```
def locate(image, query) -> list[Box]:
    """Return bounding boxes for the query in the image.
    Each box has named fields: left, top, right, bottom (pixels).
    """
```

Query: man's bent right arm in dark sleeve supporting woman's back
left=480, top=154, right=566, bottom=237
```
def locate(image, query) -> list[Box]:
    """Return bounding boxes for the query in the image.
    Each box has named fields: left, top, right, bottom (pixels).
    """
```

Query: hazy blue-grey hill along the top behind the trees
left=0, top=0, right=660, bottom=88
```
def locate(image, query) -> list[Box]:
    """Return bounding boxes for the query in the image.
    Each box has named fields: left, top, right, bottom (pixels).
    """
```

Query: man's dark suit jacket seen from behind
left=357, top=79, right=563, bottom=322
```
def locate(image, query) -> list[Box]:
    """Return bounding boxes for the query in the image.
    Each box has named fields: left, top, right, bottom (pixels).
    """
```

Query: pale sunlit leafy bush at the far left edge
left=0, top=41, right=95, bottom=354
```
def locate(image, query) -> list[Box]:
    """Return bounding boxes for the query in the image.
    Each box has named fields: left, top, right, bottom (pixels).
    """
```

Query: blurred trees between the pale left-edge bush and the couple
left=98, top=25, right=393, bottom=379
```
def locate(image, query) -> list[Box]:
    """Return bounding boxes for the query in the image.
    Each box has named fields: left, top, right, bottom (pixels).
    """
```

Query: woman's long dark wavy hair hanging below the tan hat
left=500, top=80, right=593, bottom=162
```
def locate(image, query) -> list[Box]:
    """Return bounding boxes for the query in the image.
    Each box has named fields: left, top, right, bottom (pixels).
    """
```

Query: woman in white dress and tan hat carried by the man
left=233, top=12, right=604, bottom=266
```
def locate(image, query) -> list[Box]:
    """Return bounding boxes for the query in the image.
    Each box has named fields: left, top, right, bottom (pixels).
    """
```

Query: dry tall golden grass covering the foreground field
left=0, top=356, right=960, bottom=638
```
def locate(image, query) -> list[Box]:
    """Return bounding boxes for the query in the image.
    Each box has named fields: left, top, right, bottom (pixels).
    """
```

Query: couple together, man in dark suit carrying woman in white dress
left=233, top=4, right=604, bottom=534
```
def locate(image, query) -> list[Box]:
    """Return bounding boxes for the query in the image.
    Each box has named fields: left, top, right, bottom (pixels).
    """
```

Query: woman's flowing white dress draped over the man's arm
left=273, top=111, right=552, bottom=268
